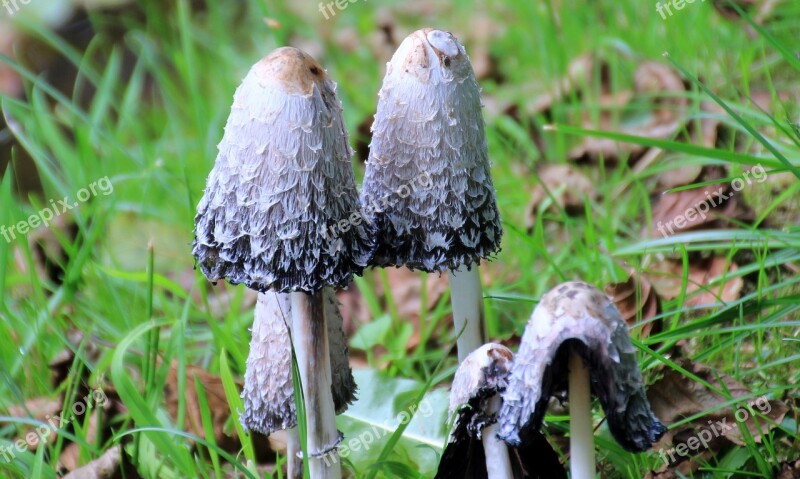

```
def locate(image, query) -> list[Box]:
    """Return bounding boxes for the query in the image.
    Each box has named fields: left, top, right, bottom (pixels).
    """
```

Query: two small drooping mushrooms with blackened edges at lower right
left=437, top=282, right=666, bottom=479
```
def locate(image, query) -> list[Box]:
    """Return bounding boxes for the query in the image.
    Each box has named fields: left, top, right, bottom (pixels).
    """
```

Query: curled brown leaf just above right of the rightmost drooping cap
left=605, top=268, right=661, bottom=339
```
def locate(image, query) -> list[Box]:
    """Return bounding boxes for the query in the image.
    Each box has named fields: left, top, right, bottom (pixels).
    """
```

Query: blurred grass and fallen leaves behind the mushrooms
left=0, top=0, right=800, bottom=479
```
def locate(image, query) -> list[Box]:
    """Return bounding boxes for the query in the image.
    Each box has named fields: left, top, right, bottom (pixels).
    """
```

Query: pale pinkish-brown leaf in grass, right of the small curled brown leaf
left=644, top=256, right=744, bottom=306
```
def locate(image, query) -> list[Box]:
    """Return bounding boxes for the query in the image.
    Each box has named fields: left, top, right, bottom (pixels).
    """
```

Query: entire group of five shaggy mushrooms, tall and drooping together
left=193, top=29, right=665, bottom=479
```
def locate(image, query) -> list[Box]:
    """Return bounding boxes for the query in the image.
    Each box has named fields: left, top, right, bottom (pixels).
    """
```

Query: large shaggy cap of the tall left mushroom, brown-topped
left=192, top=47, right=374, bottom=293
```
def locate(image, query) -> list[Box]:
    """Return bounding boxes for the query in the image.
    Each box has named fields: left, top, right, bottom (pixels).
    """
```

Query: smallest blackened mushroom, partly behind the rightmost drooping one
left=435, top=343, right=567, bottom=479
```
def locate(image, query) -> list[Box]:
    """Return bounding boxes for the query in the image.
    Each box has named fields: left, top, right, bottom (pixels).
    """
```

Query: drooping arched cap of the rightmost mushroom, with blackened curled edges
left=498, top=282, right=666, bottom=452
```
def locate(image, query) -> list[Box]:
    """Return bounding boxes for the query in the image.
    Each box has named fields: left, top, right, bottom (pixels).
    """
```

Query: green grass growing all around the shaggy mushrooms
left=0, top=0, right=800, bottom=479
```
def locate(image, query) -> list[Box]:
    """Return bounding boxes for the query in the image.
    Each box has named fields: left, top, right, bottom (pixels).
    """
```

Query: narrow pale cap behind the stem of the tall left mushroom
left=240, top=289, right=356, bottom=435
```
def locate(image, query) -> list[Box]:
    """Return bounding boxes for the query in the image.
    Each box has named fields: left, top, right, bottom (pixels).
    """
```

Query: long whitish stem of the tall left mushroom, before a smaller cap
left=291, top=291, right=342, bottom=479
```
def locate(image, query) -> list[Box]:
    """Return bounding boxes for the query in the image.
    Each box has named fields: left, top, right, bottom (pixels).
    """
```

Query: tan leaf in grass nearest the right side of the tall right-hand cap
left=525, top=165, right=598, bottom=230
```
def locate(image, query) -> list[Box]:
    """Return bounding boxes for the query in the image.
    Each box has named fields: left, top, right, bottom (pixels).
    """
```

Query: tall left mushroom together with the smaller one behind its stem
left=193, top=47, right=374, bottom=478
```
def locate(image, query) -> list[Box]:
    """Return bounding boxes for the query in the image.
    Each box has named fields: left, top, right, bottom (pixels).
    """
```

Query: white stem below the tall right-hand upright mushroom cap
left=448, top=264, right=486, bottom=362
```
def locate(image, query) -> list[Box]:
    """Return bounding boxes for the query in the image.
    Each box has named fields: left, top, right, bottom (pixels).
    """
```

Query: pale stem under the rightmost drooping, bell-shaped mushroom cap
left=569, top=353, right=596, bottom=479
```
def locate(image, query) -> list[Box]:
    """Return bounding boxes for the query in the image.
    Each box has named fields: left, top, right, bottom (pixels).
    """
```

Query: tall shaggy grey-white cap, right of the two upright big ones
left=361, top=28, right=503, bottom=272
